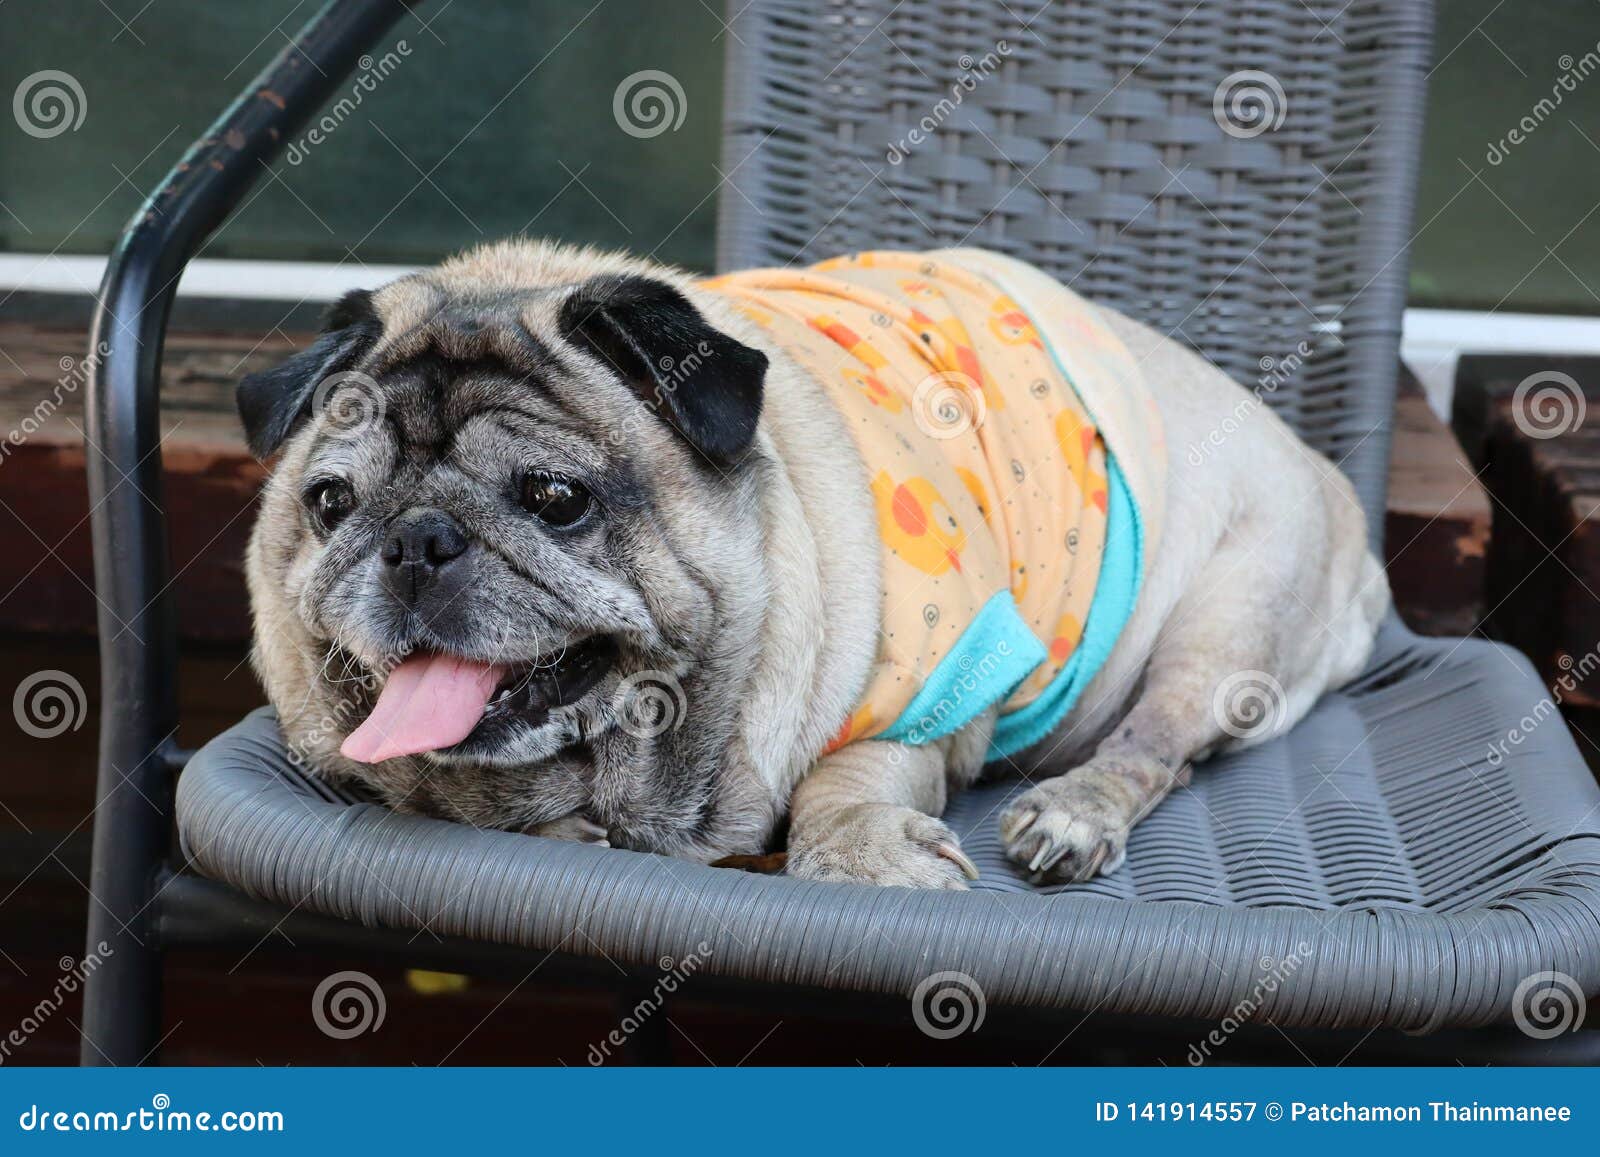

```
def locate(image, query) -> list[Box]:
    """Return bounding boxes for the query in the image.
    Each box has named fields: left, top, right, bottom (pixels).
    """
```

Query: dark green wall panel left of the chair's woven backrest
left=0, top=0, right=723, bottom=264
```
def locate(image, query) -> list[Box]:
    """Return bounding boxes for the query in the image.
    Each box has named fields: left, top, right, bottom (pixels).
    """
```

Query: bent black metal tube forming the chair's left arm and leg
left=83, top=0, right=408, bottom=1064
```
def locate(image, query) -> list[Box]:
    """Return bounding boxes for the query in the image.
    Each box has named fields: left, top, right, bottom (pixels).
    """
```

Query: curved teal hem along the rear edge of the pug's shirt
left=989, top=454, right=1144, bottom=760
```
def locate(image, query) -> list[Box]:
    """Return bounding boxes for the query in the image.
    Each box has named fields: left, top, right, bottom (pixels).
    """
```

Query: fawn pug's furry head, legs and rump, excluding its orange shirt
left=237, top=240, right=1389, bottom=888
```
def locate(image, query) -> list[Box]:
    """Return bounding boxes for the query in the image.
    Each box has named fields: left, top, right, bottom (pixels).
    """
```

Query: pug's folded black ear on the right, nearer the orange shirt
left=558, top=277, right=766, bottom=462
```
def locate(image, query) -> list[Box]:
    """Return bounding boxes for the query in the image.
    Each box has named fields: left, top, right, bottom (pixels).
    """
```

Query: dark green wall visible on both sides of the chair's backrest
left=0, top=0, right=1600, bottom=312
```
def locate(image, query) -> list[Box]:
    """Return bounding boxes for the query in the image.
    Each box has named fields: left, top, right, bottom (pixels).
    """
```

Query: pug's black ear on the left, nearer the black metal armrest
left=234, top=290, right=384, bottom=458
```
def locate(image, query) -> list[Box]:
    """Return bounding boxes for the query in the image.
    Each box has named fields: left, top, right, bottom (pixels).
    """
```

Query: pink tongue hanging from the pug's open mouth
left=339, top=655, right=506, bottom=763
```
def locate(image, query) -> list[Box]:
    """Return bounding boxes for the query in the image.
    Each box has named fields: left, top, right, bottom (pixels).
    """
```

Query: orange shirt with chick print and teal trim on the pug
left=706, top=250, right=1165, bottom=755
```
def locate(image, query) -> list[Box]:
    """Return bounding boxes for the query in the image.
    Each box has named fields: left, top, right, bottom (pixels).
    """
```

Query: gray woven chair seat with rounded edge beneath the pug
left=178, top=623, right=1600, bottom=1031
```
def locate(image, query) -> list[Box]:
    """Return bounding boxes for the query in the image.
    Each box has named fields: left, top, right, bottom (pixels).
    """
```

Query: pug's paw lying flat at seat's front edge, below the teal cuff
left=789, top=803, right=978, bottom=890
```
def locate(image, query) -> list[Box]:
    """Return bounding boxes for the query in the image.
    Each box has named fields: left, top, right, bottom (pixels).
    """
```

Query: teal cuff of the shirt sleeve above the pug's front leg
left=877, top=591, right=1050, bottom=744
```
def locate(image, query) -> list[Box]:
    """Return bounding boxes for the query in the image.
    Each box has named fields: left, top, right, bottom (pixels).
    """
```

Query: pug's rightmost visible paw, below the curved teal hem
left=1000, top=768, right=1128, bottom=883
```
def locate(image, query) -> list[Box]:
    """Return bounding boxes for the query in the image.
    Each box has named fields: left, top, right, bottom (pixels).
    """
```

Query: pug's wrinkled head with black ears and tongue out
left=240, top=241, right=766, bottom=851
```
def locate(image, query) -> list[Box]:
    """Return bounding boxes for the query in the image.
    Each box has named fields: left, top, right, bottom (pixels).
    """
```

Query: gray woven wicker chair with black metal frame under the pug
left=86, top=0, right=1600, bottom=1061
